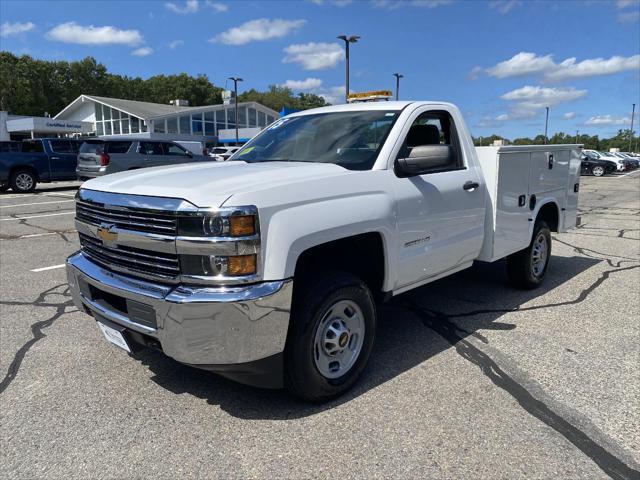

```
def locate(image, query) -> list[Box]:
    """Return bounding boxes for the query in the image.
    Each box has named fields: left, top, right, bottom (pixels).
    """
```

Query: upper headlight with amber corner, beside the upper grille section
left=178, top=209, right=258, bottom=238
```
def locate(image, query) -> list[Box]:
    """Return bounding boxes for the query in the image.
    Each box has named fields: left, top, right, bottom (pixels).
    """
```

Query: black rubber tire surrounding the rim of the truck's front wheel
left=284, top=272, right=376, bottom=403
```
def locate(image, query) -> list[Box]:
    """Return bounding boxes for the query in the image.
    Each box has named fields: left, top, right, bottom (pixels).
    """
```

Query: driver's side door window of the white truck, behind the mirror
left=398, top=111, right=464, bottom=173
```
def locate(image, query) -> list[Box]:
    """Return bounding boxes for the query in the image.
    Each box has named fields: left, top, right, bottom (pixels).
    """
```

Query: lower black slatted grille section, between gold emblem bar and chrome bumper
left=79, top=233, right=180, bottom=280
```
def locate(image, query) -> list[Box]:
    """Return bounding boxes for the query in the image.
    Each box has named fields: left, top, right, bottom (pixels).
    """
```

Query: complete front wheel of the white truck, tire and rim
left=285, top=272, right=376, bottom=402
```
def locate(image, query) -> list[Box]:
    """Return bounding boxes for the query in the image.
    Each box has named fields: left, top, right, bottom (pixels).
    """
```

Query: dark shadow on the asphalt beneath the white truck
left=139, top=256, right=601, bottom=420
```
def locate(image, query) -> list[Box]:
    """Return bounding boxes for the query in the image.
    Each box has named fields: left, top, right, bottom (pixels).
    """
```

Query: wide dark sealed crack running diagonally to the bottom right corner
left=402, top=302, right=640, bottom=480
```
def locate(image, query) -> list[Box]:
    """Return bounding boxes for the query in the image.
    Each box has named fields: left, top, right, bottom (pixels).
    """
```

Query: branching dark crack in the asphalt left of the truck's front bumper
left=0, top=283, right=77, bottom=394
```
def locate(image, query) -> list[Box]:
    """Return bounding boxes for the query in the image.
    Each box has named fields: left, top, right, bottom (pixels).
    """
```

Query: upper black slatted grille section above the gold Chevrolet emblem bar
left=76, top=201, right=177, bottom=236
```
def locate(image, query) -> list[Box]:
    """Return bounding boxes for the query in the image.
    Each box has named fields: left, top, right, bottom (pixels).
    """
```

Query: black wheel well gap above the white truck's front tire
left=295, top=233, right=385, bottom=297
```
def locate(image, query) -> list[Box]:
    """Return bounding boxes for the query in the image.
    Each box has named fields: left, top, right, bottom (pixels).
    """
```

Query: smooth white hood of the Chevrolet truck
left=82, top=161, right=351, bottom=207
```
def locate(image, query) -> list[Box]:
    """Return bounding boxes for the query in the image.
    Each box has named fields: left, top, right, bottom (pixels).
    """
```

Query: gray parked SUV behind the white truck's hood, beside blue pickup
left=76, top=139, right=202, bottom=180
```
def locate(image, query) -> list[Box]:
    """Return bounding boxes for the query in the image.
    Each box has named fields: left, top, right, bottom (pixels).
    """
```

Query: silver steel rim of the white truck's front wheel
left=313, top=300, right=365, bottom=379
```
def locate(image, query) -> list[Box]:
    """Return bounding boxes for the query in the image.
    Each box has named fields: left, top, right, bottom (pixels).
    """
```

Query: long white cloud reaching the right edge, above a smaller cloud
left=482, top=52, right=640, bottom=82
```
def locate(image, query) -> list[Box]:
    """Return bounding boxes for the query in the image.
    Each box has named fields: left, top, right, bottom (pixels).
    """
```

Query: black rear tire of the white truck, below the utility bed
left=507, top=220, right=551, bottom=290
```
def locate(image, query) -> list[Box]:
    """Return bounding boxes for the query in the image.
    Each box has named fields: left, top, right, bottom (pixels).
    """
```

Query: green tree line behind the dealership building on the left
left=0, top=52, right=327, bottom=116
